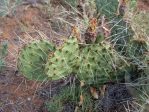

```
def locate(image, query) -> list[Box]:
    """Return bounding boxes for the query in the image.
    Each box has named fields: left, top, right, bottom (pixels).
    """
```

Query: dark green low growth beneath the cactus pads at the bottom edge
left=46, top=84, right=93, bottom=112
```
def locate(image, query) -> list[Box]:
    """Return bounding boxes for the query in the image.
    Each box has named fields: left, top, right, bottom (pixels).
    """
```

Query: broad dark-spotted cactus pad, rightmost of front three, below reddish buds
left=77, top=43, right=124, bottom=84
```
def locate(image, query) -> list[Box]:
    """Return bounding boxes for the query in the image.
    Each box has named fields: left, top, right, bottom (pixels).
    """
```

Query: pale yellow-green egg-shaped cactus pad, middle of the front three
left=46, top=37, right=79, bottom=80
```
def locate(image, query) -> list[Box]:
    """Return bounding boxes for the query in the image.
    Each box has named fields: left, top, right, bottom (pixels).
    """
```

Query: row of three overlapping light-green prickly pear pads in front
left=18, top=34, right=124, bottom=84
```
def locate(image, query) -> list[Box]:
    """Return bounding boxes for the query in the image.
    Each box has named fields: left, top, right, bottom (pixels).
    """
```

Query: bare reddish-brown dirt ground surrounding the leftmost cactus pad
left=0, top=0, right=149, bottom=112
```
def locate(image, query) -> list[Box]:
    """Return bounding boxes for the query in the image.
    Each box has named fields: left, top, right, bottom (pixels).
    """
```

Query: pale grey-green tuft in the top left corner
left=0, top=0, right=22, bottom=17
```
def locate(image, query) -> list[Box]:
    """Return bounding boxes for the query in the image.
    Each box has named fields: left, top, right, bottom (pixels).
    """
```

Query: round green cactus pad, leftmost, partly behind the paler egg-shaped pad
left=18, top=40, right=54, bottom=81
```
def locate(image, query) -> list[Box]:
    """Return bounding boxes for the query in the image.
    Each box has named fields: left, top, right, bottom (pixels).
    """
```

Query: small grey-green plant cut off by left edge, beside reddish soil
left=0, top=42, right=8, bottom=71
